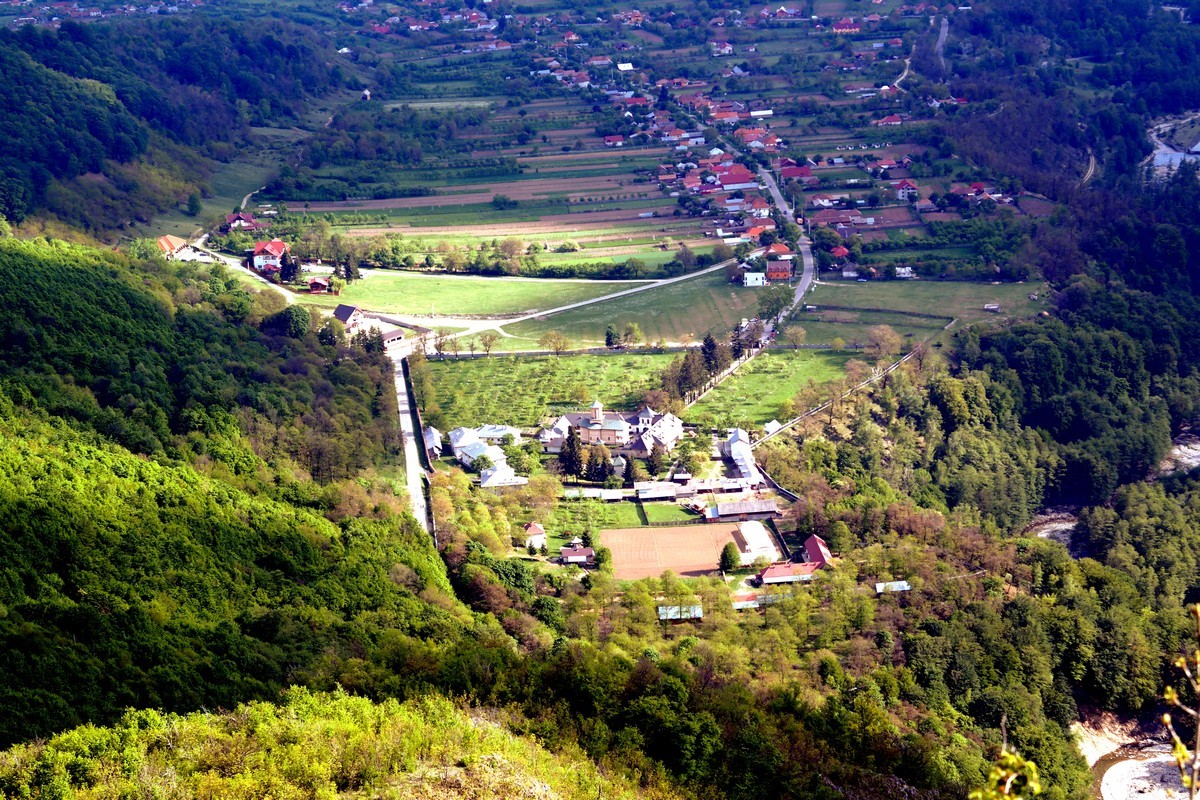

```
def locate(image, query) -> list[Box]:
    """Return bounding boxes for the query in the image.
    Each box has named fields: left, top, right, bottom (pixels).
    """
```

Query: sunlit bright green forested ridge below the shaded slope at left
left=0, top=396, right=473, bottom=744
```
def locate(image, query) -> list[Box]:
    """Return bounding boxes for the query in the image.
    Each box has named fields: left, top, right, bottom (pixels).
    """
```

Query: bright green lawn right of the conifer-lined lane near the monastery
left=684, top=350, right=852, bottom=429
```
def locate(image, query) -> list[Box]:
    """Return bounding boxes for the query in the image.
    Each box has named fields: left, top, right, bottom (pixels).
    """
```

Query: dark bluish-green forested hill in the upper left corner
left=0, top=14, right=343, bottom=234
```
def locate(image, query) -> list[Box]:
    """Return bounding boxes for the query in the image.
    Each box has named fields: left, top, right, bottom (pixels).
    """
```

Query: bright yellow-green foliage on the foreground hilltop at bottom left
left=0, top=688, right=665, bottom=800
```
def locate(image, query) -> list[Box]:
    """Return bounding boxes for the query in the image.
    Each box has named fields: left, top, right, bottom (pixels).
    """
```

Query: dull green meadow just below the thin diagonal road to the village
left=502, top=270, right=758, bottom=350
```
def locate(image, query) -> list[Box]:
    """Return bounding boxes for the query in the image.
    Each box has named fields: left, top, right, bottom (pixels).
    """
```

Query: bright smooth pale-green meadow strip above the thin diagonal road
left=302, top=271, right=638, bottom=316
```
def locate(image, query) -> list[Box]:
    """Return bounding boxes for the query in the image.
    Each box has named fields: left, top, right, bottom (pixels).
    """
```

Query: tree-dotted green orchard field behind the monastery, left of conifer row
left=430, top=354, right=676, bottom=428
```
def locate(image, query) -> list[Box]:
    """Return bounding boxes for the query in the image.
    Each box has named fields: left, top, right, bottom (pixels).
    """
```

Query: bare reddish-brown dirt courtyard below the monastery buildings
left=600, top=523, right=737, bottom=581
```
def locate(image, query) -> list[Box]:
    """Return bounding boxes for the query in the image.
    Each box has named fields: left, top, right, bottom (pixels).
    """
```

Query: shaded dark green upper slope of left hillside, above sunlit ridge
left=0, top=239, right=398, bottom=482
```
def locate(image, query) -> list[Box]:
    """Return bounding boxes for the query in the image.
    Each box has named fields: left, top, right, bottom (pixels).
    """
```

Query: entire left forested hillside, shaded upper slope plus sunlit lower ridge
left=0, top=240, right=498, bottom=741
